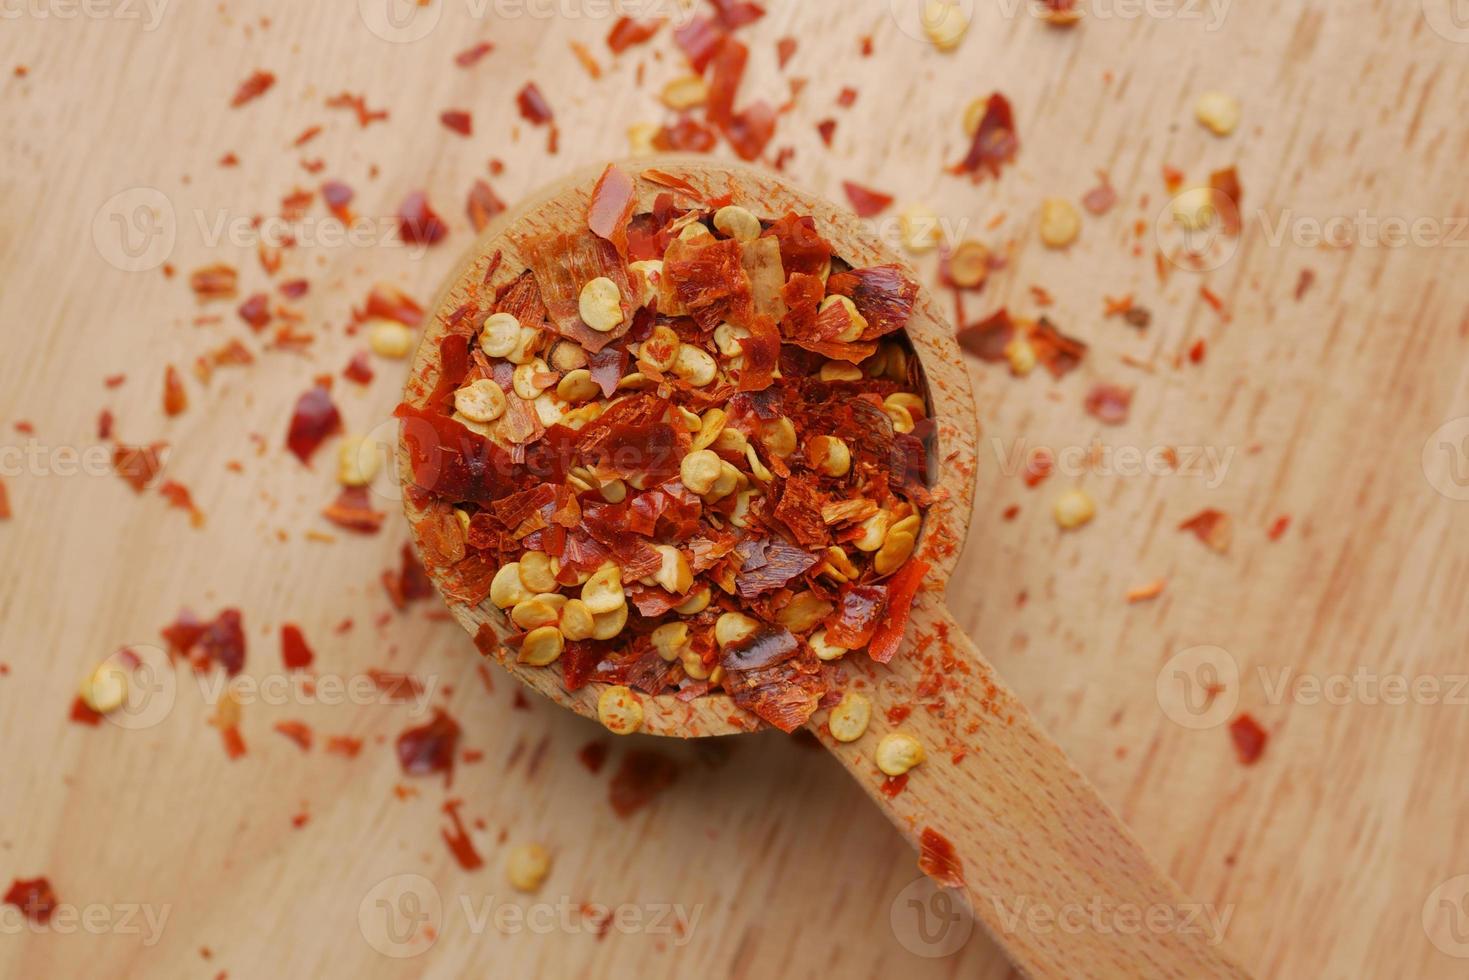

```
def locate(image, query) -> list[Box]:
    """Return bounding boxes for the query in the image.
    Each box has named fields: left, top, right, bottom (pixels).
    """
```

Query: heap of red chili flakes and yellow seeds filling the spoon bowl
left=398, top=166, right=933, bottom=732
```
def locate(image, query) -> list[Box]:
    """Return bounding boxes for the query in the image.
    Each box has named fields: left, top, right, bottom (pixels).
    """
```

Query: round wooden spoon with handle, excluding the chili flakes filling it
left=400, top=157, right=1249, bottom=977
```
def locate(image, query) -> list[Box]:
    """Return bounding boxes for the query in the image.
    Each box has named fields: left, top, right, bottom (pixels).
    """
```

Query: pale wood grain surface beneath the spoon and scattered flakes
left=0, top=0, right=1469, bottom=977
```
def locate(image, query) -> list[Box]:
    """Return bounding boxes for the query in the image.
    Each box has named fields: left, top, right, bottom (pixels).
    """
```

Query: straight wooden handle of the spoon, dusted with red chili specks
left=812, top=602, right=1249, bottom=979
